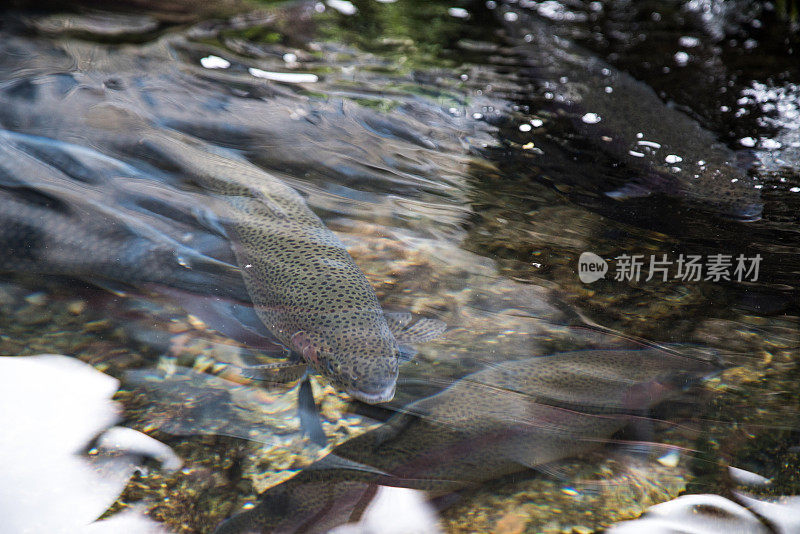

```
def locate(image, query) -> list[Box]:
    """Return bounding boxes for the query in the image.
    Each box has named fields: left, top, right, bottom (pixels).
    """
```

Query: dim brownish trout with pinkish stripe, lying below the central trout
left=216, top=349, right=717, bottom=534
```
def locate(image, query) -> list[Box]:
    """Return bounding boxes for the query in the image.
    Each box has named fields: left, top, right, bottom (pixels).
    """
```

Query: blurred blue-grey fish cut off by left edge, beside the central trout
left=0, top=130, right=249, bottom=301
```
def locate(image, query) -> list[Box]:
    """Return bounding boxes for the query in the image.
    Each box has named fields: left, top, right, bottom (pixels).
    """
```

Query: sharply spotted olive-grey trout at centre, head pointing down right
left=92, top=106, right=445, bottom=403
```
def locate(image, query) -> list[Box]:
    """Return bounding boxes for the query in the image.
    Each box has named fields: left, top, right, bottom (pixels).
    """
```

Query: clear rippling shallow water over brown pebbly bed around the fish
left=0, top=0, right=800, bottom=532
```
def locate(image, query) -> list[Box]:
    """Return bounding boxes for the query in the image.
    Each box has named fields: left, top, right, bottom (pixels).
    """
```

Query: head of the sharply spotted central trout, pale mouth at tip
left=291, top=316, right=400, bottom=404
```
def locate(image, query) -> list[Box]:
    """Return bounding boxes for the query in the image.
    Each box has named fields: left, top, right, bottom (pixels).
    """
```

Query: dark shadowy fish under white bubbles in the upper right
left=498, top=5, right=762, bottom=221
